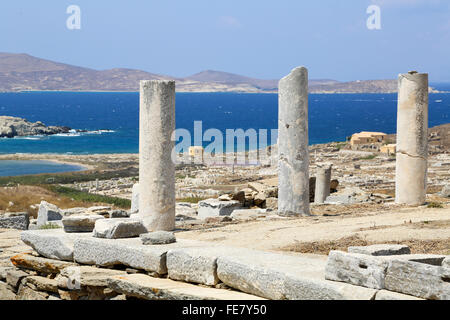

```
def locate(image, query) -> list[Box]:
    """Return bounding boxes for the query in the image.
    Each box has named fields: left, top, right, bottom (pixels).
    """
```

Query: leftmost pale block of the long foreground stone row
left=21, top=229, right=92, bottom=261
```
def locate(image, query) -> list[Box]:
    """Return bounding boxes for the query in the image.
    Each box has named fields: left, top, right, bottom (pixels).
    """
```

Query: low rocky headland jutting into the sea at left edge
left=0, top=116, right=71, bottom=138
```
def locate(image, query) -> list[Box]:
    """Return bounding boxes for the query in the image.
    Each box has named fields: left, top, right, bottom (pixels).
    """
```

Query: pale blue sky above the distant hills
left=0, top=0, right=450, bottom=81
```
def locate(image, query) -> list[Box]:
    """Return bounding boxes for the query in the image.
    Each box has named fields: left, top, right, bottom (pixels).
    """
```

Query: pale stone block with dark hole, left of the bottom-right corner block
left=325, top=251, right=389, bottom=289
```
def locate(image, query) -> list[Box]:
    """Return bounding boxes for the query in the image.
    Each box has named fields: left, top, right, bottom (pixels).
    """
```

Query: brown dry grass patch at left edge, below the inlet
left=0, top=186, right=91, bottom=217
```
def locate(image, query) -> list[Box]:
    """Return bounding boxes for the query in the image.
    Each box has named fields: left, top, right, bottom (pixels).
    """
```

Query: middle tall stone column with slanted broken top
left=278, top=67, right=310, bottom=216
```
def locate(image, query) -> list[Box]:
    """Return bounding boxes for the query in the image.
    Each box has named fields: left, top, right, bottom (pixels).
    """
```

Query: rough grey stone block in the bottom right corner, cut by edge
left=385, top=260, right=450, bottom=300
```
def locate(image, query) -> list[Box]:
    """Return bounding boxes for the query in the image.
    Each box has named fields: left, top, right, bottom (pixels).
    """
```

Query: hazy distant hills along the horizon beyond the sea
left=0, top=53, right=436, bottom=93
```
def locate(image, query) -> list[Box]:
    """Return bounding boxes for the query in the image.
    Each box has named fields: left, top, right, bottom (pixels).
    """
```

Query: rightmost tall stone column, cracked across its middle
left=395, top=71, right=428, bottom=205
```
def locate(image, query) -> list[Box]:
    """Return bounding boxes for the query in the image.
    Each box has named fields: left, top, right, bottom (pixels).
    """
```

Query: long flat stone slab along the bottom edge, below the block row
left=108, top=274, right=262, bottom=300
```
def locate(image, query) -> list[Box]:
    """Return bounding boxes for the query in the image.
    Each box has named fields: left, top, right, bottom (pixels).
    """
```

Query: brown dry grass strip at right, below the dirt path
left=281, top=235, right=450, bottom=255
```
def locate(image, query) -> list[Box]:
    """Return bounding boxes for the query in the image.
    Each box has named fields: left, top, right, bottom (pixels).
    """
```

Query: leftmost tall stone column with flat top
left=138, top=80, right=175, bottom=231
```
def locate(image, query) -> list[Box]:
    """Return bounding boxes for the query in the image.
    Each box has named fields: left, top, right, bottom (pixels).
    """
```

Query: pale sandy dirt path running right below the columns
left=177, top=205, right=450, bottom=254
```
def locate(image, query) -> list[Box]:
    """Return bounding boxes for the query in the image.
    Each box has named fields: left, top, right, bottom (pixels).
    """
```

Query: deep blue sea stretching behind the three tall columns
left=0, top=84, right=450, bottom=154
